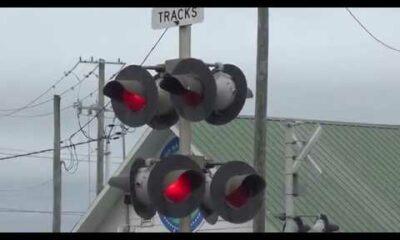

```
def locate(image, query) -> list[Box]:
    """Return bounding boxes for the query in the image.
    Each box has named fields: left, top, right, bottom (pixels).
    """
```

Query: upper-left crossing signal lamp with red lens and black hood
left=103, top=65, right=179, bottom=129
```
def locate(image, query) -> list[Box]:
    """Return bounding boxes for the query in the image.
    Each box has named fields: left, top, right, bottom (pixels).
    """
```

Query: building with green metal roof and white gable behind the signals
left=73, top=117, right=400, bottom=232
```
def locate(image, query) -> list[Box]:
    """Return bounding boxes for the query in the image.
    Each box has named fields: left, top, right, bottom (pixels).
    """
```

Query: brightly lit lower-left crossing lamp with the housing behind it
left=109, top=155, right=204, bottom=219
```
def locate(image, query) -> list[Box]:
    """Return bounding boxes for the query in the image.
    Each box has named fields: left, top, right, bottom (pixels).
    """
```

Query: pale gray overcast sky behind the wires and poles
left=0, top=8, right=400, bottom=231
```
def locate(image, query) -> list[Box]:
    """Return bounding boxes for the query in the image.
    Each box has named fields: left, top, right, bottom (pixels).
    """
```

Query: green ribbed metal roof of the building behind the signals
left=193, top=117, right=400, bottom=232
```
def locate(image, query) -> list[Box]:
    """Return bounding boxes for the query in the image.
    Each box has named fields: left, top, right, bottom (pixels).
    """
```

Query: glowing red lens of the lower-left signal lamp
left=164, top=174, right=192, bottom=203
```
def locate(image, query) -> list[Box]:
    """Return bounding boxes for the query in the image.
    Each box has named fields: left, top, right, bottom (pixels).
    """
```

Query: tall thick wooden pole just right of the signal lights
left=253, top=8, right=269, bottom=232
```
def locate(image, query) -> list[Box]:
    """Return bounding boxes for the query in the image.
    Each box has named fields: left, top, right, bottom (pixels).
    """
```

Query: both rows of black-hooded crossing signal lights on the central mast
left=103, top=58, right=260, bottom=224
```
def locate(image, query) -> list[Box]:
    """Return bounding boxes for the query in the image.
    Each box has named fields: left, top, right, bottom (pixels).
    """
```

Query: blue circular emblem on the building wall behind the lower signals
left=158, top=137, right=204, bottom=232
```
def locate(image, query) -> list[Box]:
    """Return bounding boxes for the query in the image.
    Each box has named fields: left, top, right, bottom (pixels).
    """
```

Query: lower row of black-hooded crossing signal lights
left=109, top=155, right=266, bottom=224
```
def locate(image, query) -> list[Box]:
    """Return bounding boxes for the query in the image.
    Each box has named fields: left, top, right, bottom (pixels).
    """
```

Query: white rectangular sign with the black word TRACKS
left=151, top=8, right=204, bottom=29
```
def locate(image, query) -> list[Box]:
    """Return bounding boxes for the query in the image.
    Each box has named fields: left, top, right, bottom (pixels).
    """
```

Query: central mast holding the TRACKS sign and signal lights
left=178, top=25, right=192, bottom=232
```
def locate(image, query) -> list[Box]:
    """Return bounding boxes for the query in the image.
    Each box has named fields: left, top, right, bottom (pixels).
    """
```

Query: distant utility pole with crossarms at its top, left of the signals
left=96, top=59, right=105, bottom=195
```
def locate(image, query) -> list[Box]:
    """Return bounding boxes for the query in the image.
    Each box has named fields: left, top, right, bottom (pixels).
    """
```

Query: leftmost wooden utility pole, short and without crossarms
left=53, top=95, right=61, bottom=232
